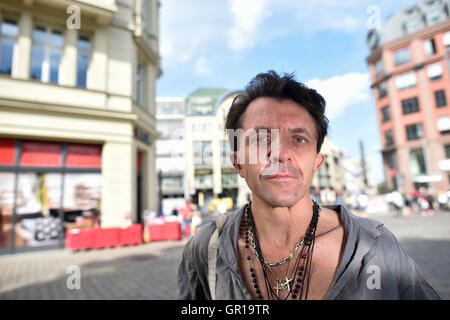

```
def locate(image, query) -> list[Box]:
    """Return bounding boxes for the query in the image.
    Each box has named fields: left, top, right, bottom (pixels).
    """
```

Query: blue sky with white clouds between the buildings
left=156, top=0, right=417, bottom=182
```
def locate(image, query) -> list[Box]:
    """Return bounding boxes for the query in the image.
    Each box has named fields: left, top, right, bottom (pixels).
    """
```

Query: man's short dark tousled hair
left=225, top=70, right=328, bottom=152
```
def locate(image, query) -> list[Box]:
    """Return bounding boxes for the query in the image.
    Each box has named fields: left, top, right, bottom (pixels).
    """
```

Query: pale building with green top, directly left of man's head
left=185, top=88, right=250, bottom=213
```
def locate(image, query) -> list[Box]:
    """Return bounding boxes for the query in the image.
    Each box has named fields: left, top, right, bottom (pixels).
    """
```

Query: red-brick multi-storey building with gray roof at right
left=367, top=0, right=450, bottom=193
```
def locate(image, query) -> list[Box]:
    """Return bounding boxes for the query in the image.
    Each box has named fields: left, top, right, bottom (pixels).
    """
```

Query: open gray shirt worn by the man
left=178, top=205, right=440, bottom=300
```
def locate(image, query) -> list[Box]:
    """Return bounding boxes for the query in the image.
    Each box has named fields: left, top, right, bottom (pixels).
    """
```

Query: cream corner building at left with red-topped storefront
left=0, top=0, right=161, bottom=255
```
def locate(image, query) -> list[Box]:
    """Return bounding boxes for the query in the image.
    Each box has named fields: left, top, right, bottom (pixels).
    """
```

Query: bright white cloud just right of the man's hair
left=305, top=72, right=370, bottom=119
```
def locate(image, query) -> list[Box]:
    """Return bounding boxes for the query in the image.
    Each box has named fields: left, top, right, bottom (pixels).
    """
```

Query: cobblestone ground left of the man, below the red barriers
left=0, top=241, right=184, bottom=300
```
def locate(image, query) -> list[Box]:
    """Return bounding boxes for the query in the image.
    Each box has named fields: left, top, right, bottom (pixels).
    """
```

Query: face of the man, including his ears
left=232, top=97, right=324, bottom=207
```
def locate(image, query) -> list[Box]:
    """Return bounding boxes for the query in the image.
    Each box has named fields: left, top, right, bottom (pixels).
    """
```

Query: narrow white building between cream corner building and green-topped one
left=156, top=97, right=189, bottom=215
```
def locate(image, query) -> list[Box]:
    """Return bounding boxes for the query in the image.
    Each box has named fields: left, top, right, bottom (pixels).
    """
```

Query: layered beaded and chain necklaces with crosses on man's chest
left=241, top=200, right=320, bottom=300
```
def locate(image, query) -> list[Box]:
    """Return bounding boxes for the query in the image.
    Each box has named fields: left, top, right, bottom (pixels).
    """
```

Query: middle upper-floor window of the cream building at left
left=31, top=26, right=64, bottom=83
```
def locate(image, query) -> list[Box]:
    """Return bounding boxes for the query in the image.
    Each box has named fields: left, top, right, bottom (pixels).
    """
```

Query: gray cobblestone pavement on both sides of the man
left=0, top=213, right=450, bottom=300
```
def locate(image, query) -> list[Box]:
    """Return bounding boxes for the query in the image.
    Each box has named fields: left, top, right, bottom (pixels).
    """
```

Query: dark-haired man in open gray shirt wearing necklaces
left=178, top=71, right=439, bottom=300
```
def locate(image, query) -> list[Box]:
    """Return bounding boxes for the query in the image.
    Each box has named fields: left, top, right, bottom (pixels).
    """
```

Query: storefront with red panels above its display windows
left=0, top=138, right=102, bottom=253
